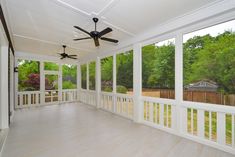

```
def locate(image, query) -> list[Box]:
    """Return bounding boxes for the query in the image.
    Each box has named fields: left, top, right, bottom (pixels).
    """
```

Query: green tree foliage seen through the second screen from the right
left=142, top=43, right=175, bottom=89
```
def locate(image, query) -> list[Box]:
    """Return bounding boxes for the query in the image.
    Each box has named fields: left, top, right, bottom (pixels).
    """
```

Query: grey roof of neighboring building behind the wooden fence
left=184, top=80, right=219, bottom=92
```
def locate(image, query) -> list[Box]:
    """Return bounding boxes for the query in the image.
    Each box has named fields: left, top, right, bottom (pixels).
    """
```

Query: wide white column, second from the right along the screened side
left=133, top=43, right=143, bottom=123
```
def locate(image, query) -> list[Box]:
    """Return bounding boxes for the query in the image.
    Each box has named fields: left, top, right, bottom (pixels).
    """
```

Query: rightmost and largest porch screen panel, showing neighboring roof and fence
left=183, top=20, right=235, bottom=106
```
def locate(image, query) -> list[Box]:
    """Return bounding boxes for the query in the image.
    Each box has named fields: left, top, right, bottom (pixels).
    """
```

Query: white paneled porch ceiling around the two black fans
left=6, top=0, right=219, bottom=58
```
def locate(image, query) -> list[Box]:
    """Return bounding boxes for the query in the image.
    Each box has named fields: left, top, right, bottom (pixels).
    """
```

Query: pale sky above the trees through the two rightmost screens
left=155, top=20, right=235, bottom=46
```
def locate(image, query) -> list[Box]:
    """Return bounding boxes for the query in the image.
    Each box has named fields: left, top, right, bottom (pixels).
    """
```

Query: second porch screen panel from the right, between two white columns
left=142, top=38, right=175, bottom=99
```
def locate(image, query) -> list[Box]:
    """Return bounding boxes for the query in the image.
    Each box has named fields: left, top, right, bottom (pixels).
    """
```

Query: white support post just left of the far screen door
left=40, top=61, right=45, bottom=105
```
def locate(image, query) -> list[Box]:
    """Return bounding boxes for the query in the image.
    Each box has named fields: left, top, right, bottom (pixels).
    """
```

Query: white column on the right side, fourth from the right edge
left=95, top=57, right=101, bottom=108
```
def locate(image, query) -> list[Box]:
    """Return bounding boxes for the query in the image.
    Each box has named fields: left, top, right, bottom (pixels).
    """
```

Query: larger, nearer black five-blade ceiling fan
left=73, top=18, right=118, bottom=46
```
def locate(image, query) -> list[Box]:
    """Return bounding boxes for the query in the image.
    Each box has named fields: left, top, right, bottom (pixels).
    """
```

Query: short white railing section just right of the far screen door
left=62, top=89, right=78, bottom=102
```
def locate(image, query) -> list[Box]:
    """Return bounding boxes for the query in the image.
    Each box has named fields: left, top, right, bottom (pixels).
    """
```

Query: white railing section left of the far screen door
left=15, top=91, right=41, bottom=108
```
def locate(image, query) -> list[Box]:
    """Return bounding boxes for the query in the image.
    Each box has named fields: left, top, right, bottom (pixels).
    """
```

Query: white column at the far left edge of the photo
left=0, top=46, right=9, bottom=129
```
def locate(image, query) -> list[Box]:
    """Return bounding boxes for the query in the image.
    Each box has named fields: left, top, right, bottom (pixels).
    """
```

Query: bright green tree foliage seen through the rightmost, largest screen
left=184, top=31, right=235, bottom=93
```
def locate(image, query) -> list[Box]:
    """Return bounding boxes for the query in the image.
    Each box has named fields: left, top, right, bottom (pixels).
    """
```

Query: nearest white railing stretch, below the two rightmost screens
left=141, top=97, right=235, bottom=154
